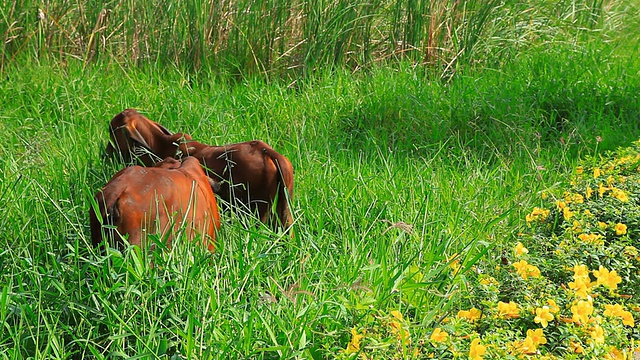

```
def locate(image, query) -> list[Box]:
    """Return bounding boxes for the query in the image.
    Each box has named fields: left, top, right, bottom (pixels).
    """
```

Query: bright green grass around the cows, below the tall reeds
left=0, top=42, right=640, bottom=358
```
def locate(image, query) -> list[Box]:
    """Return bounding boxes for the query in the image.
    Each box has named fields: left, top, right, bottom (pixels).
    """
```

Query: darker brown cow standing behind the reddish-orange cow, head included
left=107, top=109, right=293, bottom=232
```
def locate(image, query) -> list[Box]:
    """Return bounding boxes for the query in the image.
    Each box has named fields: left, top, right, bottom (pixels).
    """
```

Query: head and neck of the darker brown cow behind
left=106, top=109, right=191, bottom=166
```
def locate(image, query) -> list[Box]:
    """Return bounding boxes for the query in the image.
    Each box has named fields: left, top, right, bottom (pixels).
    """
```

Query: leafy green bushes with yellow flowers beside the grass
left=336, top=141, right=640, bottom=359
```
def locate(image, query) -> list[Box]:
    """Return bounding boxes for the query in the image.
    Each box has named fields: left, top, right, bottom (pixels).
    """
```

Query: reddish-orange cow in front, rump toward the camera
left=89, top=157, right=220, bottom=251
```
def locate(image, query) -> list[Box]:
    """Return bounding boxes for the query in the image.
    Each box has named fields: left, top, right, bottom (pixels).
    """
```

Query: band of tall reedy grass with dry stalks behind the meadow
left=0, top=0, right=637, bottom=77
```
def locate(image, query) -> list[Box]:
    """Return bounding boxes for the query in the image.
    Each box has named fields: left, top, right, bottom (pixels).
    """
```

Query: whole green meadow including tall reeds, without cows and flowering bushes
left=0, top=1, right=640, bottom=359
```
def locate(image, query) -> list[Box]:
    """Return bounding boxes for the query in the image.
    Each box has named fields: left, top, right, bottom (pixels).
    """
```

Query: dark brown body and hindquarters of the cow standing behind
left=178, top=140, right=293, bottom=228
